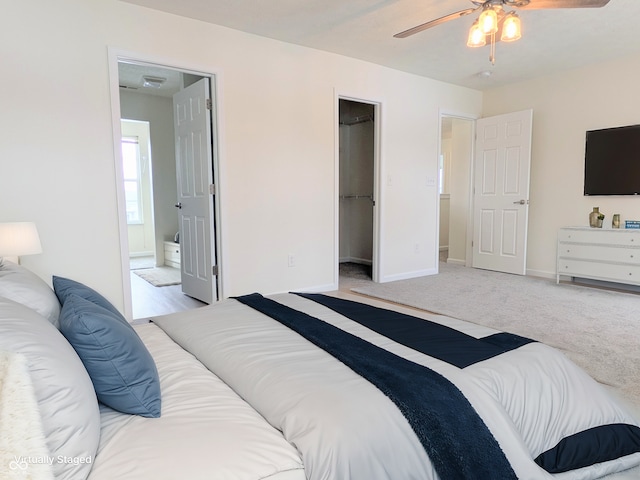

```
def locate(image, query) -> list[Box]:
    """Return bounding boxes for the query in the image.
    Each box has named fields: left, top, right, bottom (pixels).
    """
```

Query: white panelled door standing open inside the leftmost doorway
left=173, top=78, right=217, bottom=303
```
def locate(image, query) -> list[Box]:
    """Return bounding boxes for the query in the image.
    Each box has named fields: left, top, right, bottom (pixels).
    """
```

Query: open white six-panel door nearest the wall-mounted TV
left=472, top=110, right=533, bottom=275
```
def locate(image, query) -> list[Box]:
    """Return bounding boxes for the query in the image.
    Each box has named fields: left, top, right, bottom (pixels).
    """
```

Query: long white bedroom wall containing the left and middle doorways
left=0, top=0, right=480, bottom=312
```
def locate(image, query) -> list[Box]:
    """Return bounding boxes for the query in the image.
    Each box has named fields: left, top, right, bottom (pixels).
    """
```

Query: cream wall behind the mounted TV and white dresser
left=483, top=51, right=640, bottom=276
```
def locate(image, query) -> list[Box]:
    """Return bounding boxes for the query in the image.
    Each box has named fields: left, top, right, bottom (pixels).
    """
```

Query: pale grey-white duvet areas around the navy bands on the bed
left=154, top=295, right=640, bottom=480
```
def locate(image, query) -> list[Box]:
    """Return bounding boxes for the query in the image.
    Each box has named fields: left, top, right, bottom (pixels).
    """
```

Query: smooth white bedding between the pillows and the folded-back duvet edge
left=89, top=324, right=305, bottom=480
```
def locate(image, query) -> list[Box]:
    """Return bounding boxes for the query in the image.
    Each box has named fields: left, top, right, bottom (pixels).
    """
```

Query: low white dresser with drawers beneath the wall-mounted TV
left=556, top=227, right=640, bottom=285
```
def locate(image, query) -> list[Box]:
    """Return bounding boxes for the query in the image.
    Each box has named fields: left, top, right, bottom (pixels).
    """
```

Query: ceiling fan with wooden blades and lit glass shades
left=394, top=0, right=609, bottom=64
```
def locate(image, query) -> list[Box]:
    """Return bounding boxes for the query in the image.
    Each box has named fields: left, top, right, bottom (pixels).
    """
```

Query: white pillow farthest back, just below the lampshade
left=0, top=260, right=60, bottom=328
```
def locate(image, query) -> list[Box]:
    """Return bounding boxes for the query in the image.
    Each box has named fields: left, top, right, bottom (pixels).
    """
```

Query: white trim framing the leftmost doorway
left=107, top=47, right=226, bottom=320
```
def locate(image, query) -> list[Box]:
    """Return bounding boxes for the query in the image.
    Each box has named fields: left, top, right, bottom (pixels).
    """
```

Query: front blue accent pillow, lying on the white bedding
left=60, top=294, right=161, bottom=418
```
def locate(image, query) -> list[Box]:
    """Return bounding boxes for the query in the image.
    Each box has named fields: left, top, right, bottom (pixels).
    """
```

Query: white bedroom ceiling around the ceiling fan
left=122, top=0, right=640, bottom=90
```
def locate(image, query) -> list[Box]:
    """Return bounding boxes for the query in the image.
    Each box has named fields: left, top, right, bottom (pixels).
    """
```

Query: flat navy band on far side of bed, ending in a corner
left=296, top=293, right=534, bottom=368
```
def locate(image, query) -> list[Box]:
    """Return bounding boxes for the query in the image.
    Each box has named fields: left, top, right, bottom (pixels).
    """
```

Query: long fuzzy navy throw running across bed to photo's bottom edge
left=236, top=293, right=517, bottom=480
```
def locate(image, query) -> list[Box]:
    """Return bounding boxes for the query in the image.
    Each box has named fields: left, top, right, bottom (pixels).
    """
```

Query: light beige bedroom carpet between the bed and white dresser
left=352, top=263, right=640, bottom=405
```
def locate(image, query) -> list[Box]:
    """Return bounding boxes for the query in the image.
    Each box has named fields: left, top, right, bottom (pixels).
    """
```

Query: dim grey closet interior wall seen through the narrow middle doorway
left=339, top=100, right=375, bottom=265
